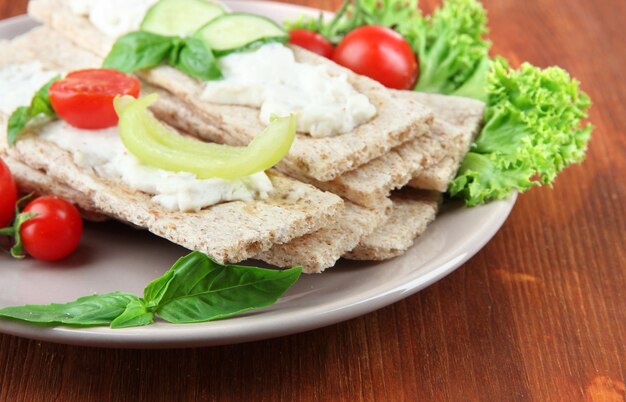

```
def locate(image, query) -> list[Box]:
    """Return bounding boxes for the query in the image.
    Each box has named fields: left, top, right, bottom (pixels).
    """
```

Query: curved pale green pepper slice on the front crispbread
left=115, top=94, right=296, bottom=179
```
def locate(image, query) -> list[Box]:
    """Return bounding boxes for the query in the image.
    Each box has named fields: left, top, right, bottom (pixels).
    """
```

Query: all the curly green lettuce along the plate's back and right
left=287, top=0, right=592, bottom=206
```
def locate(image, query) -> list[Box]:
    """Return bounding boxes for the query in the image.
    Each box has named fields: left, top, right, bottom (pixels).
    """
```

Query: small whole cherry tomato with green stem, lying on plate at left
left=20, top=196, right=83, bottom=261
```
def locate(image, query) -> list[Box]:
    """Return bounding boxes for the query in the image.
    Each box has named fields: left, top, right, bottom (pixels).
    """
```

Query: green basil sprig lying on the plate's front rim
left=0, top=251, right=302, bottom=328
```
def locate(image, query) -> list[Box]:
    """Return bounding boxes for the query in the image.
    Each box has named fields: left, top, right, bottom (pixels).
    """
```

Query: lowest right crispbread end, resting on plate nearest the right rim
left=344, top=189, right=441, bottom=261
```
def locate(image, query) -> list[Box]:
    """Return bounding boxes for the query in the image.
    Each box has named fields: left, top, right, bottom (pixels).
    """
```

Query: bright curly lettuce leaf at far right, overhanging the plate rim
left=449, top=59, right=592, bottom=206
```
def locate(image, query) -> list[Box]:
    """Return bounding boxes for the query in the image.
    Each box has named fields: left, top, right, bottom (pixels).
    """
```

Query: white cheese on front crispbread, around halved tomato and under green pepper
left=0, top=63, right=273, bottom=212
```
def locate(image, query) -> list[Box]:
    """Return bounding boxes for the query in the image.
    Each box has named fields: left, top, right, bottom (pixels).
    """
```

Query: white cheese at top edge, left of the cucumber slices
left=70, top=0, right=157, bottom=38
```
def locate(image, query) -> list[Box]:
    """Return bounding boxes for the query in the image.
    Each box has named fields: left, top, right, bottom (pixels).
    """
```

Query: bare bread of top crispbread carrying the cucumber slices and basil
left=29, top=0, right=432, bottom=181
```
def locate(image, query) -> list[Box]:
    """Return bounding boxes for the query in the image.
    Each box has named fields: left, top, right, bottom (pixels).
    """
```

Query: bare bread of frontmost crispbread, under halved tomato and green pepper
left=0, top=28, right=343, bottom=262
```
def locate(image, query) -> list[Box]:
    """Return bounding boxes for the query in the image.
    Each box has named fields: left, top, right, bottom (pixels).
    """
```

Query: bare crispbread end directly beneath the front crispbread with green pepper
left=256, top=202, right=391, bottom=274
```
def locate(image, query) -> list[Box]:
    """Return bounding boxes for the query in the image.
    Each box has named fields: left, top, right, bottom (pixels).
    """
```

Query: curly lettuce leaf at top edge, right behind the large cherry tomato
left=414, top=0, right=491, bottom=101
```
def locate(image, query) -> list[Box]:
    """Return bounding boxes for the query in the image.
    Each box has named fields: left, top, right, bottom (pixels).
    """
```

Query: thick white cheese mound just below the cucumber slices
left=202, top=43, right=376, bottom=137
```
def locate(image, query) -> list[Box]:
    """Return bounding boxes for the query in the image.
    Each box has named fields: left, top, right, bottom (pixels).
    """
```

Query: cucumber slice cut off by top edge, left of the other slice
left=140, top=0, right=226, bottom=36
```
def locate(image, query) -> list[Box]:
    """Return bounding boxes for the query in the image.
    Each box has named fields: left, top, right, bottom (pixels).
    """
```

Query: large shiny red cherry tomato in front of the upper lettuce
left=333, top=25, right=419, bottom=89
